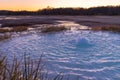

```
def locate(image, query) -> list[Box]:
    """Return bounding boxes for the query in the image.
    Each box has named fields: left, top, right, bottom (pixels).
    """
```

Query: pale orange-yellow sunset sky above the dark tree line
left=0, top=0, right=120, bottom=11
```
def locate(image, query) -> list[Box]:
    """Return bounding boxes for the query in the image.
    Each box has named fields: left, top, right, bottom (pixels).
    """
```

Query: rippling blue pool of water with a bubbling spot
left=0, top=31, right=120, bottom=80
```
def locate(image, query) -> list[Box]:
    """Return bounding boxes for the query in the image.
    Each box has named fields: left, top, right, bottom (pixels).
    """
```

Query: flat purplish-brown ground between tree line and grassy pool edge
left=0, top=16, right=120, bottom=27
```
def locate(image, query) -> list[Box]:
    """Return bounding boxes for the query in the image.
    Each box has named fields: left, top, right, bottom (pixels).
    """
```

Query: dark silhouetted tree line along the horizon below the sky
left=0, top=6, right=120, bottom=15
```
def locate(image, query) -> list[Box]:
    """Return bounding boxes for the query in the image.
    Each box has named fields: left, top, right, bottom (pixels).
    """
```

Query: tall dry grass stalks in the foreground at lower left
left=0, top=54, right=63, bottom=80
